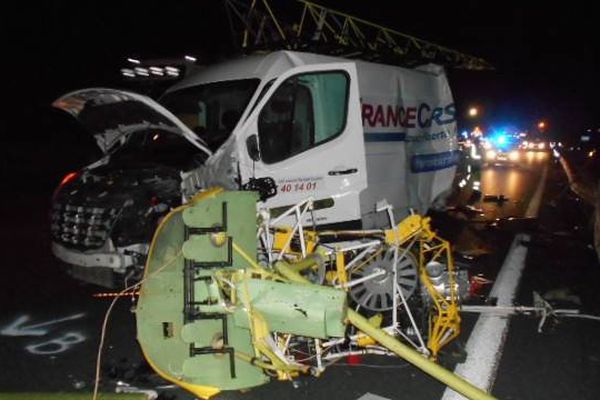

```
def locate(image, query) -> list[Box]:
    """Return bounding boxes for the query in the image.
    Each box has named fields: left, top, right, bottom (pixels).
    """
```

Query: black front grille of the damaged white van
left=50, top=203, right=118, bottom=249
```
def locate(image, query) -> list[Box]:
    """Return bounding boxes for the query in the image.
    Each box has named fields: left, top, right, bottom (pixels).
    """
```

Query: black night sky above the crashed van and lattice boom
left=0, top=0, right=600, bottom=141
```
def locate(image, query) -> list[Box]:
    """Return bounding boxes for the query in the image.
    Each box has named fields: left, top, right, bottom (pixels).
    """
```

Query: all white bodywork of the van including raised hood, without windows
left=54, top=51, right=458, bottom=278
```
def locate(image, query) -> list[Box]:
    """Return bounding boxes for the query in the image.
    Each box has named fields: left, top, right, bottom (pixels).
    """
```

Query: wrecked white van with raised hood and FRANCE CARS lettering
left=51, top=51, right=459, bottom=286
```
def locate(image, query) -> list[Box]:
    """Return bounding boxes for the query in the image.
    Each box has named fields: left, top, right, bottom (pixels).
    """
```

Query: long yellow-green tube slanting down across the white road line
left=275, top=262, right=495, bottom=400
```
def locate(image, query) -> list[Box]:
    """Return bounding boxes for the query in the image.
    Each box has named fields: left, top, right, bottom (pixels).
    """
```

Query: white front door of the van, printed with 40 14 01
left=240, top=63, right=367, bottom=225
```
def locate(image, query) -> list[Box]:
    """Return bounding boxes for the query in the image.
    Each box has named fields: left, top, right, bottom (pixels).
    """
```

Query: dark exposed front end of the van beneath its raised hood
left=50, top=164, right=181, bottom=251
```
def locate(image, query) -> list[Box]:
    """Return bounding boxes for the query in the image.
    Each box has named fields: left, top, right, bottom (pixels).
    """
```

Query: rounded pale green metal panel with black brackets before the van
left=136, top=192, right=269, bottom=390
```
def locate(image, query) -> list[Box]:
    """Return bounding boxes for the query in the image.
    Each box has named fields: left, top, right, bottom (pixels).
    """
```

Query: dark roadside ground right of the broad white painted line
left=494, top=154, right=600, bottom=399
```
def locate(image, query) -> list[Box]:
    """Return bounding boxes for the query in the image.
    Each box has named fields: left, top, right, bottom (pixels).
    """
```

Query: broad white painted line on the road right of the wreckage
left=442, top=164, right=548, bottom=400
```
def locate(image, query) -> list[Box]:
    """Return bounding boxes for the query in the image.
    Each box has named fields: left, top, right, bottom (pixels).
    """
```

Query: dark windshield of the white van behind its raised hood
left=160, top=79, right=260, bottom=151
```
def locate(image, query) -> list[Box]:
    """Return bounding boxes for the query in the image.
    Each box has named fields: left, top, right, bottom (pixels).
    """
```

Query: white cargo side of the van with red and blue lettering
left=356, top=62, right=458, bottom=227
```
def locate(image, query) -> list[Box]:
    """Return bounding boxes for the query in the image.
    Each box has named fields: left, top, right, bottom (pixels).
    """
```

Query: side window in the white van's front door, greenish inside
left=258, top=71, right=348, bottom=164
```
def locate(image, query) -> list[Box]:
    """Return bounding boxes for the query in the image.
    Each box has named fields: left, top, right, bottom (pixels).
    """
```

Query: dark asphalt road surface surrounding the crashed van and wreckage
left=0, top=148, right=600, bottom=400
